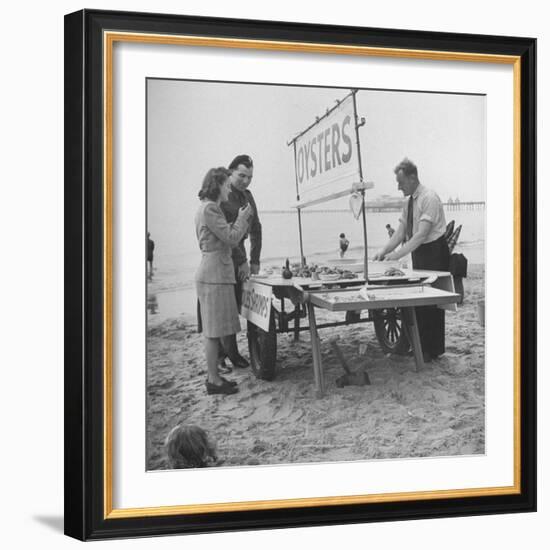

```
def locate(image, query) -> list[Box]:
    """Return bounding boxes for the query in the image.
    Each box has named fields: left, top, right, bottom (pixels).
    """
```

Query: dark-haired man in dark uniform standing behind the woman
left=221, top=155, right=262, bottom=368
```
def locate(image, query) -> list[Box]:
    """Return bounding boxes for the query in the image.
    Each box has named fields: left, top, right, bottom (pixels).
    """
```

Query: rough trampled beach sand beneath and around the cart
left=147, top=266, right=485, bottom=470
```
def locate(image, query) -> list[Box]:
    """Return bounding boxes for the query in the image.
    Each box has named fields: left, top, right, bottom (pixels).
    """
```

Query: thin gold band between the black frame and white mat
left=103, top=31, right=521, bottom=519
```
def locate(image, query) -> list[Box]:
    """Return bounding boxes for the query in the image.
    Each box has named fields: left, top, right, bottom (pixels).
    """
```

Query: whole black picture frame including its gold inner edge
left=65, top=10, right=537, bottom=540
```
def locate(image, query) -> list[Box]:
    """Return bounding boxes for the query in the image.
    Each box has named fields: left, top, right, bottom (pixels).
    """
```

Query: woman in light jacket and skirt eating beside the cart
left=195, top=168, right=252, bottom=394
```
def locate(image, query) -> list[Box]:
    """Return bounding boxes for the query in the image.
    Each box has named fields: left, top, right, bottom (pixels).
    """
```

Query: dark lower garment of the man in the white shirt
left=412, top=235, right=449, bottom=357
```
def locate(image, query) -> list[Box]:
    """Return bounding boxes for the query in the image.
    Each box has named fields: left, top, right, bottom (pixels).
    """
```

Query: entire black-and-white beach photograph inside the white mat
left=143, top=80, right=487, bottom=471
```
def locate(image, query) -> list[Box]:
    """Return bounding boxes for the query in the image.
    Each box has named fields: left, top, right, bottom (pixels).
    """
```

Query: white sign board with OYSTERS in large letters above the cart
left=294, top=94, right=360, bottom=207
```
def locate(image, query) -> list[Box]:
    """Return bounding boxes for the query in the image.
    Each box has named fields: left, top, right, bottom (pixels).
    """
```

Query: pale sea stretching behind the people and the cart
left=147, top=210, right=485, bottom=321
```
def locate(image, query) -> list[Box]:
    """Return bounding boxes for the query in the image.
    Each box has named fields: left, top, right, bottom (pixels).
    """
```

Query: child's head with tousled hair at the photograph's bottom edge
left=164, top=424, right=217, bottom=468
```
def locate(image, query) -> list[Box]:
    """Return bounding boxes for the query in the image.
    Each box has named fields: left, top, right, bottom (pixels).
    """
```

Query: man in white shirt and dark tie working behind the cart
left=374, top=158, right=449, bottom=361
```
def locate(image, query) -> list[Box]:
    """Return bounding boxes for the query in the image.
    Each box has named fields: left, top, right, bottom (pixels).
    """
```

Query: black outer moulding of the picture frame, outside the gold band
left=65, top=10, right=537, bottom=540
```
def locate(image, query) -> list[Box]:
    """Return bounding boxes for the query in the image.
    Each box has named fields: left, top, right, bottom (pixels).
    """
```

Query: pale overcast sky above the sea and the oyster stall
left=147, top=80, right=486, bottom=252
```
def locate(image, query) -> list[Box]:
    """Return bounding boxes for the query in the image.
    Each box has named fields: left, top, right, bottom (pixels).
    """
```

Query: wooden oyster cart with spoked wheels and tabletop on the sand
left=247, top=270, right=459, bottom=396
